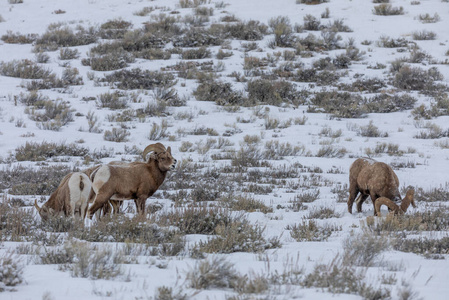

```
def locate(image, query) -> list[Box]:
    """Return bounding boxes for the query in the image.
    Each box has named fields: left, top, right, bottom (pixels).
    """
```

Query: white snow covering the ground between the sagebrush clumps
left=0, top=0, right=449, bottom=300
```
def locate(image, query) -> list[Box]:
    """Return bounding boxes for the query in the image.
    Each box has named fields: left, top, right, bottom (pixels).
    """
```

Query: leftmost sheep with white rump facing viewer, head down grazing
left=34, top=172, right=92, bottom=221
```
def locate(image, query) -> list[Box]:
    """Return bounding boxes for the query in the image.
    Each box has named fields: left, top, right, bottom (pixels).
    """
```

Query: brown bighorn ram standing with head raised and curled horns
left=88, top=143, right=176, bottom=218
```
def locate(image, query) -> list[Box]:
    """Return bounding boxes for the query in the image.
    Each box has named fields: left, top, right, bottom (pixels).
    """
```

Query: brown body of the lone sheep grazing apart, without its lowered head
left=348, top=158, right=401, bottom=215
